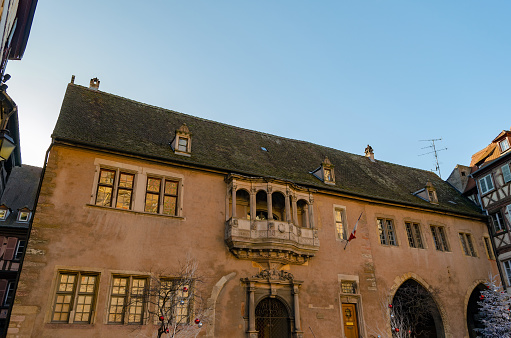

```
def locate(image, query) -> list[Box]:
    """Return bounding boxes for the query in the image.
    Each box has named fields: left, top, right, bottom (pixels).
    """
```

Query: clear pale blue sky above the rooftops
left=7, top=0, right=511, bottom=179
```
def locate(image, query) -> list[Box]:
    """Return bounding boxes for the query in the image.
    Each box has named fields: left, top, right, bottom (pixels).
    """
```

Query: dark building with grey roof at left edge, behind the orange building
left=0, top=165, right=41, bottom=337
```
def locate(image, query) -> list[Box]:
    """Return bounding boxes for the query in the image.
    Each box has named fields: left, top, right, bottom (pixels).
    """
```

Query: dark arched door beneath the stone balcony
left=255, top=297, right=291, bottom=338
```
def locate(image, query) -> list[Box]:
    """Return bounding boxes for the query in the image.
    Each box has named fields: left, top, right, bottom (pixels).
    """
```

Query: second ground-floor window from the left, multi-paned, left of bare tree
left=108, top=276, right=147, bottom=324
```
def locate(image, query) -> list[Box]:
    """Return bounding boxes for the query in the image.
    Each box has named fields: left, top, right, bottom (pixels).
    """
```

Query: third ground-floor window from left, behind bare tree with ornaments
left=158, top=279, right=193, bottom=324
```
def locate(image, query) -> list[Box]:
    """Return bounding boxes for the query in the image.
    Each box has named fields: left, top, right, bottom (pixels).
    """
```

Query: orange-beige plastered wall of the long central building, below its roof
left=10, top=84, right=497, bottom=338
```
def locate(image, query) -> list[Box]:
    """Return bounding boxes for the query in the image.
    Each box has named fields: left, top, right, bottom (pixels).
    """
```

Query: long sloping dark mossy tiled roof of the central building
left=52, top=84, right=481, bottom=216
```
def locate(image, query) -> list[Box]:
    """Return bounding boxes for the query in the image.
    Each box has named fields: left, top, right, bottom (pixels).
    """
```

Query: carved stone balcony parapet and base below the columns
left=225, top=218, right=319, bottom=264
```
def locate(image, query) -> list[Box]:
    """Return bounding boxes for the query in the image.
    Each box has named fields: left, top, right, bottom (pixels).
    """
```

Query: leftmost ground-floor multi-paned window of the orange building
left=52, top=272, right=98, bottom=323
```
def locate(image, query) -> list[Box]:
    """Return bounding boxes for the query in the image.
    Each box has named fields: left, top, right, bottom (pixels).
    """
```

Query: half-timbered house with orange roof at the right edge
left=468, top=130, right=511, bottom=288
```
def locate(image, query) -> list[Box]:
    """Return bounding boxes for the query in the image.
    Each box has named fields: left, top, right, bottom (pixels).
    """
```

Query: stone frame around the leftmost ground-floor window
left=44, top=267, right=101, bottom=325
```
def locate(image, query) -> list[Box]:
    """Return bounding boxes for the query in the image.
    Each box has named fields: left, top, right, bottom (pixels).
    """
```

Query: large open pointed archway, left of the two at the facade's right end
left=391, top=279, right=445, bottom=338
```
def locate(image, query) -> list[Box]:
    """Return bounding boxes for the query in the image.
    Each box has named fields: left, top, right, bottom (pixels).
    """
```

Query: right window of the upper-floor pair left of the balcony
left=144, top=177, right=179, bottom=216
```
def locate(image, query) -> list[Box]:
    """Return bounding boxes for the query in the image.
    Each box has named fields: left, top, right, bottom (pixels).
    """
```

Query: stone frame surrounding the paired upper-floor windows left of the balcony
left=87, top=158, right=185, bottom=219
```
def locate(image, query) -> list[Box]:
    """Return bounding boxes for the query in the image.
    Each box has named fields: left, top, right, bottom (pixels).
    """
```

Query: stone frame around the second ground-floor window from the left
left=105, top=272, right=150, bottom=325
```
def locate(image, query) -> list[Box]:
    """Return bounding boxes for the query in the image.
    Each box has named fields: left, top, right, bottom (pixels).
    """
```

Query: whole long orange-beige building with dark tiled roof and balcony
left=9, top=79, right=497, bottom=338
